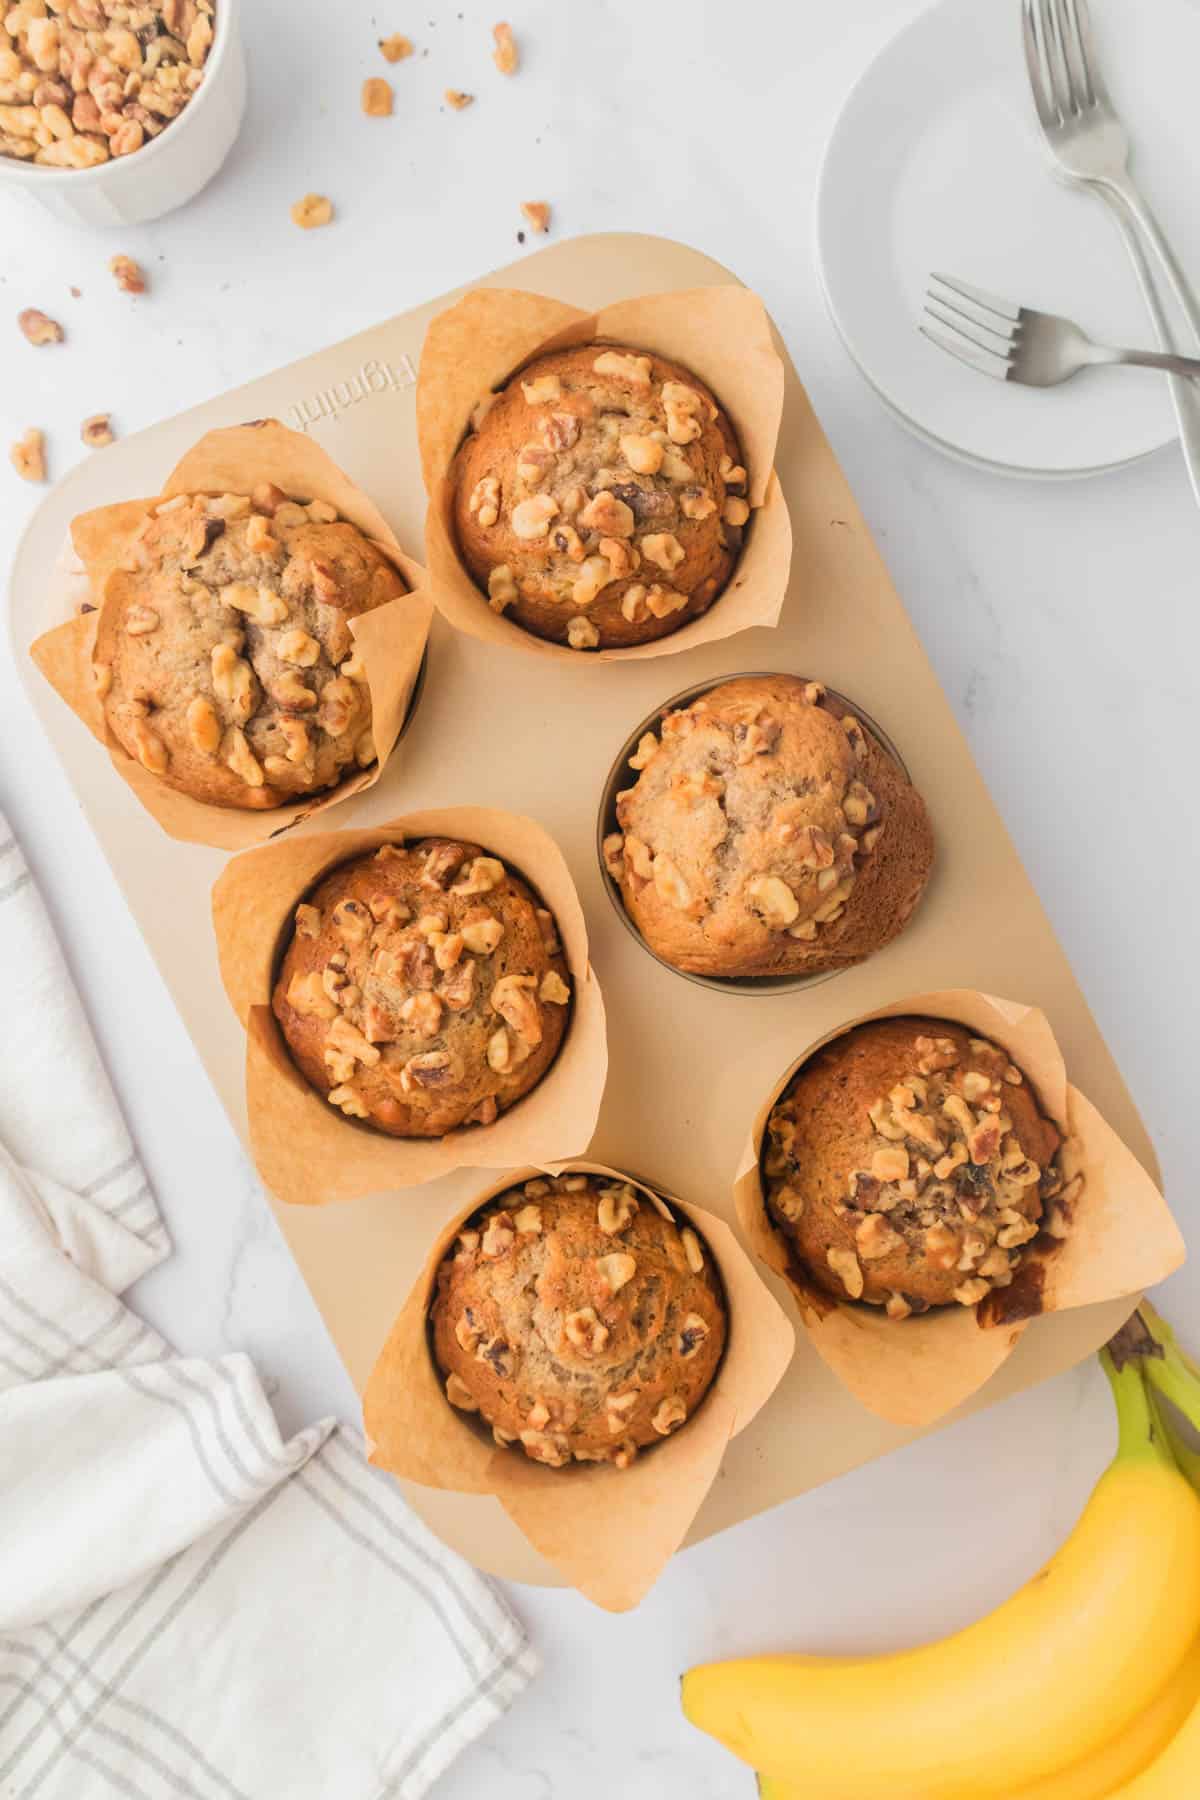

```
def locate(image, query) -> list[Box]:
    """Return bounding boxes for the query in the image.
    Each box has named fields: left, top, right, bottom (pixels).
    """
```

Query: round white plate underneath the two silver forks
left=817, top=0, right=1200, bottom=475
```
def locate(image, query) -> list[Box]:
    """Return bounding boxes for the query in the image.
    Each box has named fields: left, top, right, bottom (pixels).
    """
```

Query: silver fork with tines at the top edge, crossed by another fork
left=1022, top=0, right=1200, bottom=500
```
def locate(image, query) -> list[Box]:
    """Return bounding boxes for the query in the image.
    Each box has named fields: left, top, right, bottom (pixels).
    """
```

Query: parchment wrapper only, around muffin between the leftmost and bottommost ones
left=212, top=806, right=608, bottom=1206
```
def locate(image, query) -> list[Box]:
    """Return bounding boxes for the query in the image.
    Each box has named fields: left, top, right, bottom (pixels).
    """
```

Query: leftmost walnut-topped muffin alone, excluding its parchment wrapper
left=94, top=482, right=405, bottom=810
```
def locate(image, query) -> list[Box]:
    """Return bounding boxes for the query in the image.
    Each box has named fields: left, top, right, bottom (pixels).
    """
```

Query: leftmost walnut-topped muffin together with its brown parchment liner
left=31, top=419, right=432, bottom=850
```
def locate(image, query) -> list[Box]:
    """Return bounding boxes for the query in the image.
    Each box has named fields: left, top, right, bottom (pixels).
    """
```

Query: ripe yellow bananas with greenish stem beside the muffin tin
left=682, top=1305, right=1200, bottom=1800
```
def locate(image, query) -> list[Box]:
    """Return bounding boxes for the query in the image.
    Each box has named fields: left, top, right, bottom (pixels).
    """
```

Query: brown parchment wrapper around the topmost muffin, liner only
left=417, top=283, right=792, bottom=662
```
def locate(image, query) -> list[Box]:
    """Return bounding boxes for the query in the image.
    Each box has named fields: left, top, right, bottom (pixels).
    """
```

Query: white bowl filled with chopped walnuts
left=0, top=0, right=246, bottom=225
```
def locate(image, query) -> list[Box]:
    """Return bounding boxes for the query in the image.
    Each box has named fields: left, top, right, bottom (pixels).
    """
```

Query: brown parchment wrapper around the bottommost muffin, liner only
left=363, top=1159, right=795, bottom=1613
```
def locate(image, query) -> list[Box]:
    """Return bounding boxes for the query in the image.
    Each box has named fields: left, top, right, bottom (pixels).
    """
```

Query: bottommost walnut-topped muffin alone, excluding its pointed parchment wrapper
left=430, top=1174, right=727, bottom=1469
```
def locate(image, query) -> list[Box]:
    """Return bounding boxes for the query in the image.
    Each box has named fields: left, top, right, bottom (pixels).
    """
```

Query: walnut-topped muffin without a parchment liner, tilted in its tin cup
left=604, top=675, right=934, bottom=976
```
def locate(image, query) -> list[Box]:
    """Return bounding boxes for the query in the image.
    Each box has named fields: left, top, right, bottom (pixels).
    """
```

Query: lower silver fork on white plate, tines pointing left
left=921, top=275, right=1200, bottom=387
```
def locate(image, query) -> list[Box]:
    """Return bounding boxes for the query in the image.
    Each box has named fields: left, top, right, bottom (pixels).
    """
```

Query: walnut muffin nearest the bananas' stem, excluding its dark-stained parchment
left=763, top=1019, right=1083, bottom=1319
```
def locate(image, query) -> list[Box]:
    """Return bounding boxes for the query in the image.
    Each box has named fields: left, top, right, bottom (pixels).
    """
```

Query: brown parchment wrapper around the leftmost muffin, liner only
left=29, top=419, right=434, bottom=850
